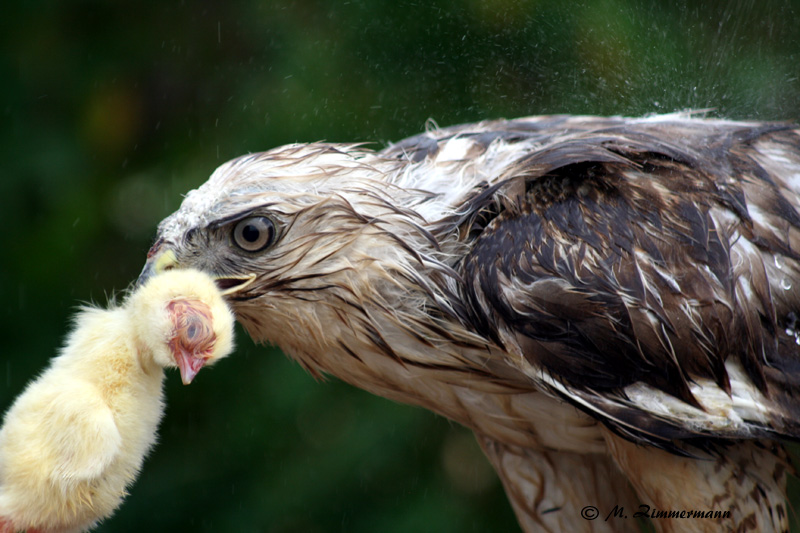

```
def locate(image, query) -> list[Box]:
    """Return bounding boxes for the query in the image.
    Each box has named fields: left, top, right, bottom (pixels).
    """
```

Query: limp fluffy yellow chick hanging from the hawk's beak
left=0, top=270, right=233, bottom=532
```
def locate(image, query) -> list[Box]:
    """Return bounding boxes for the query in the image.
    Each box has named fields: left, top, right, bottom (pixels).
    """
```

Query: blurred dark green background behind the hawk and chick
left=0, top=0, right=800, bottom=532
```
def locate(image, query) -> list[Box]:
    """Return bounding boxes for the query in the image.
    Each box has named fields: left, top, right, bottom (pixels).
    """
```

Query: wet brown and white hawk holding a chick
left=142, top=113, right=800, bottom=531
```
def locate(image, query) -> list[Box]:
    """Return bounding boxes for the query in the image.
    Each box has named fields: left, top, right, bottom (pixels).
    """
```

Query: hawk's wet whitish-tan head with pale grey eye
left=140, top=143, right=454, bottom=358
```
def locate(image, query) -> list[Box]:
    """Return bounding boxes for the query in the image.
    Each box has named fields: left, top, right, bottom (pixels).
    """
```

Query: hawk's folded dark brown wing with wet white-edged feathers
left=461, top=121, right=800, bottom=443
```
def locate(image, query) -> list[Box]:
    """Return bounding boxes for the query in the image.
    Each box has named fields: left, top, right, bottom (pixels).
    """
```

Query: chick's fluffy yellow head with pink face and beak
left=127, top=270, right=233, bottom=385
